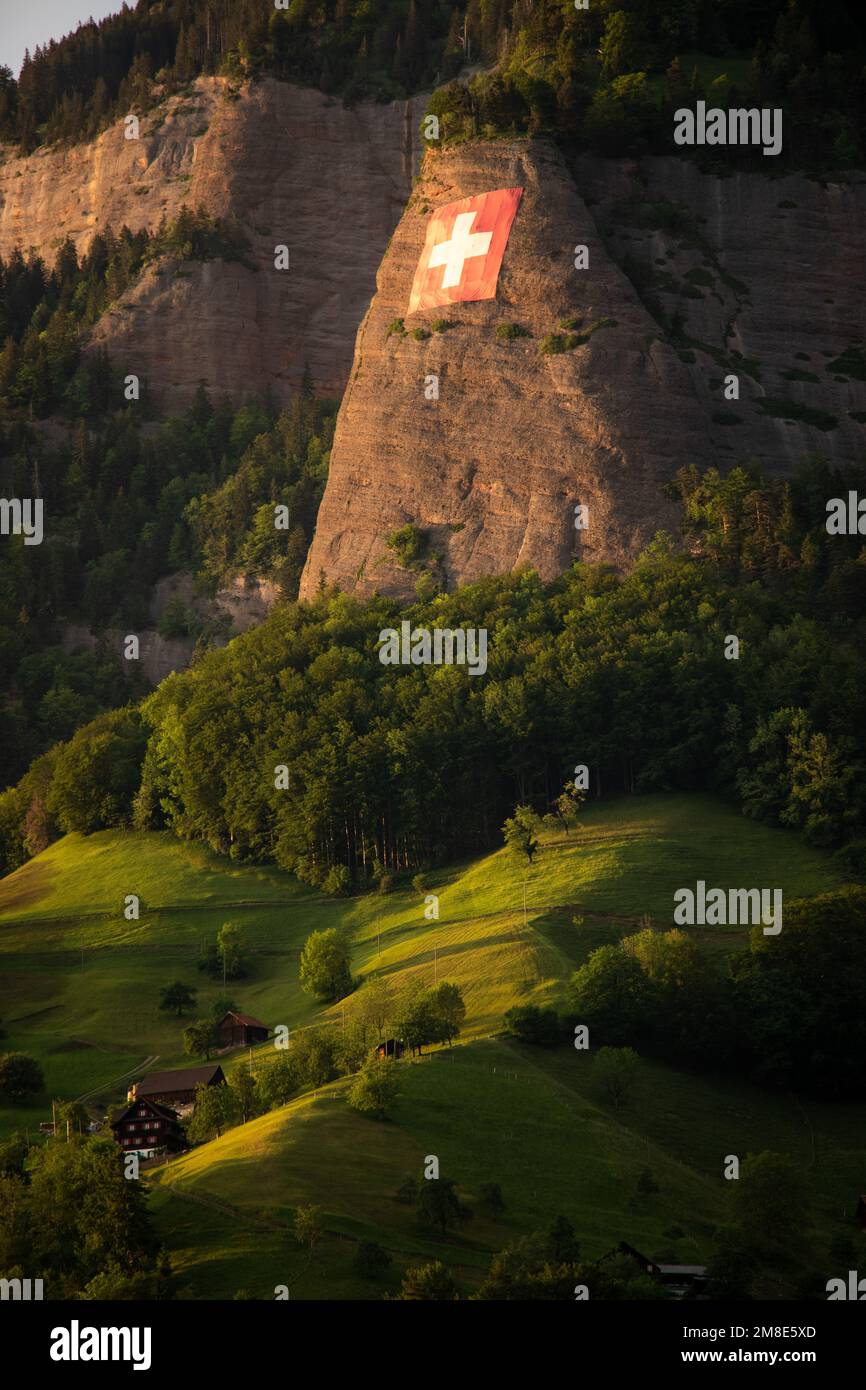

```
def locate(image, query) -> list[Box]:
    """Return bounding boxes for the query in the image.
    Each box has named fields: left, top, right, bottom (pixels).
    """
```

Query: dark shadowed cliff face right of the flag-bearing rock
left=575, top=157, right=866, bottom=475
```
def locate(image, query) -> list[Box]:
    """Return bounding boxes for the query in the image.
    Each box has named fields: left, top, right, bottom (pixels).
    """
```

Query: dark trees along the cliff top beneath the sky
left=0, top=0, right=866, bottom=167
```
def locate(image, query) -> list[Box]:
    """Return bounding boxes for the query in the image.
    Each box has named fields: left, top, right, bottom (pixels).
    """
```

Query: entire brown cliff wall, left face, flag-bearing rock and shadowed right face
left=0, top=78, right=866, bottom=596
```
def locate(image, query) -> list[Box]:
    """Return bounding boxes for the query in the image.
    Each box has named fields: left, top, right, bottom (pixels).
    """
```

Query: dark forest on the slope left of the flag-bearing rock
left=0, top=380, right=336, bottom=784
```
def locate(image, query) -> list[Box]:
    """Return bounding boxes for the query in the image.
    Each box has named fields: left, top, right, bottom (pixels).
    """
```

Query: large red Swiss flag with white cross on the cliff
left=409, top=188, right=523, bottom=314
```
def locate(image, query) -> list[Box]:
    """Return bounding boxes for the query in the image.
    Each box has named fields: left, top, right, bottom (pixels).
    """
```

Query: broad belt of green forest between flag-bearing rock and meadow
left=0, top=461, right=866, bottom=883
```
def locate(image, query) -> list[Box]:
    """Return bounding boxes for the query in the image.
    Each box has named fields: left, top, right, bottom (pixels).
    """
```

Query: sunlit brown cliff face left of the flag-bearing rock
left=0, top=78, right=424, bottom=409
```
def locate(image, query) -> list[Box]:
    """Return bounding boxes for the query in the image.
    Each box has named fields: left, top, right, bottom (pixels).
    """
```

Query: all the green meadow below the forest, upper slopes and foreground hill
left=0, top=795, right=866, bottom=1298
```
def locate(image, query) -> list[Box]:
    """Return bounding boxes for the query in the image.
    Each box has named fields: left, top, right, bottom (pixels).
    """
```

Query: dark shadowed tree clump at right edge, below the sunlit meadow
left=569, top=887, right=866, bottom=1099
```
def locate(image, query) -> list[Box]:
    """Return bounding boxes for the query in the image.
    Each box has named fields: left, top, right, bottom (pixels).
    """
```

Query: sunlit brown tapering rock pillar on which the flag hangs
left=302, top=140, right=712, bottom=596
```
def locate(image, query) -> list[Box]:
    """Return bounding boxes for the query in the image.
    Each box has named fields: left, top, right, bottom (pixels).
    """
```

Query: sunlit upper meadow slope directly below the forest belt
left=0, top=795, right=840, bottom=1134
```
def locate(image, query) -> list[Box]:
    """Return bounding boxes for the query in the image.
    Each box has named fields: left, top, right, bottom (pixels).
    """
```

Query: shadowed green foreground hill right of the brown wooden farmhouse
left=154, top=1041, right=866, bottom=1298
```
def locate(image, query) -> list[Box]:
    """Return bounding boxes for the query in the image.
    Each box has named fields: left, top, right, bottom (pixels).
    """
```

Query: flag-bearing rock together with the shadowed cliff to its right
left=302, top=140, right=866, bottom=598
